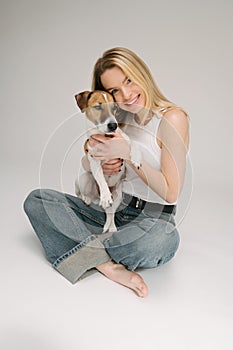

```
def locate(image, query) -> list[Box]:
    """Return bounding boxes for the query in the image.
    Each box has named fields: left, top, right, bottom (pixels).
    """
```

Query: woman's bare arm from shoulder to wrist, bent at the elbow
left=125, top=110, right=189, bottom=203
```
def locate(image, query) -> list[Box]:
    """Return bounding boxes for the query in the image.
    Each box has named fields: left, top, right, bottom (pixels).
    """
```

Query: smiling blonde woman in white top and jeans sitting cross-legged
left=24, top=48, right=189, bottom=297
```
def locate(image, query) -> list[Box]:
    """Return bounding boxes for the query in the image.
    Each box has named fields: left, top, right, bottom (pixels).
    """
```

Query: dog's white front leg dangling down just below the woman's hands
left=90, top=157, right=112, bottom=209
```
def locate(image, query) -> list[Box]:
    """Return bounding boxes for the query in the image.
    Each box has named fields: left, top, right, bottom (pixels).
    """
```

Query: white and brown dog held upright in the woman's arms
left=75, top=90, right=139, bottom=233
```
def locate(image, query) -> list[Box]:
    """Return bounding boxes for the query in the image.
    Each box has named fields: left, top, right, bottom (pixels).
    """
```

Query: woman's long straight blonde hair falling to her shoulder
left=92, top=47, right=181, bottom=114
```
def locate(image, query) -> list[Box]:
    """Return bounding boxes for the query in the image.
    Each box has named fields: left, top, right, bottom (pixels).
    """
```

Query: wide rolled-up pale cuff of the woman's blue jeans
left=53, top=235, right=111, bottom=284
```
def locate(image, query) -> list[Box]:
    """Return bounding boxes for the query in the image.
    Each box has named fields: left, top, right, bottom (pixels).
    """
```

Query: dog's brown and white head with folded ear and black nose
left=75, top=90, right=118, bottom=134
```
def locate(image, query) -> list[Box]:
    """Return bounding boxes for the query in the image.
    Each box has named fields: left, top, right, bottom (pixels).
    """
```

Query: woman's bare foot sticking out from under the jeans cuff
left=96, top=261, right=148, bottom=297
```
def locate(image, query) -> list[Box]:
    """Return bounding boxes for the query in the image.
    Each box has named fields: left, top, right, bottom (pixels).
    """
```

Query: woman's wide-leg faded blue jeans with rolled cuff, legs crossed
left=24, top=189, right=179, bottom=283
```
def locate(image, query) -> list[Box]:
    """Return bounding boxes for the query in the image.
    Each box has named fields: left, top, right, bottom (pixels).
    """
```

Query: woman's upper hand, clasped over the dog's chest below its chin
left=89, top=133, right=130, bottom=163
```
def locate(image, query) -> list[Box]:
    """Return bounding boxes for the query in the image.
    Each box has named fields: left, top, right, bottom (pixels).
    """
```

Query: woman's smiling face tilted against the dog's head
left=100, top=66, right=146, bottom=114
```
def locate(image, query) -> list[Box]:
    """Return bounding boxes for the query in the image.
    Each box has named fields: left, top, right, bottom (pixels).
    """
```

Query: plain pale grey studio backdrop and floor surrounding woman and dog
left=0, top=0, right=233, bottom=350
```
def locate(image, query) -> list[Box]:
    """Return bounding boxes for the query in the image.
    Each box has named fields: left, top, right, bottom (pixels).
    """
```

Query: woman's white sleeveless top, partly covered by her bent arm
left=123, top=115, right=175, bottom=204
